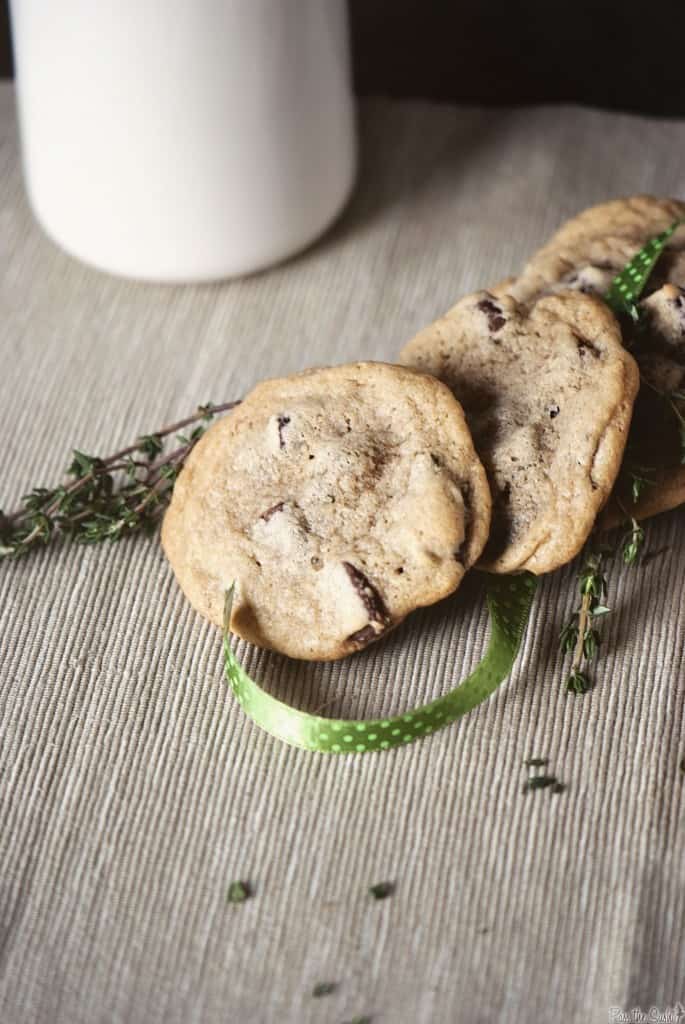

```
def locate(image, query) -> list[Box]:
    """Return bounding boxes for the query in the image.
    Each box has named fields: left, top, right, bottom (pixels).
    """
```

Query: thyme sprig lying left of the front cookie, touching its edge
left=0, top=401, right=239, bottom=560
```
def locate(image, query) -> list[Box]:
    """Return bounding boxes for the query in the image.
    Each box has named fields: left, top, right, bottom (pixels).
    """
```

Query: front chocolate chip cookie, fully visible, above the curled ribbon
left=162, top=362, right=490, bottom=659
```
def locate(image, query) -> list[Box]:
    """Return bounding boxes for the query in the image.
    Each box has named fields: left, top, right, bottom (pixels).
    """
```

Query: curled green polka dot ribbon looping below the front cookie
left=223, top=572, right=537, bottom=754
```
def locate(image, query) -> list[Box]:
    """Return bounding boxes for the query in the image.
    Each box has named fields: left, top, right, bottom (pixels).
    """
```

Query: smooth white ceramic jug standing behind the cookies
left=11, top=0, right=355, bottom=282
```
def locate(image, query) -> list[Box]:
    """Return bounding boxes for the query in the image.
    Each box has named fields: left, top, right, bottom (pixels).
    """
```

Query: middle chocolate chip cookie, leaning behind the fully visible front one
left=400, top=292, right=639, bottom=573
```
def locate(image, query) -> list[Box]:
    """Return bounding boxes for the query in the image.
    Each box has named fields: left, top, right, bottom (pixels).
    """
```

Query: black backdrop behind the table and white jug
left=0, top=0, right=685, bottom=115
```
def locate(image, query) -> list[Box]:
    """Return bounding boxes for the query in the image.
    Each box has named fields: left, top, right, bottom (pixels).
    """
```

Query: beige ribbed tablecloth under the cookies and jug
left=0, top=86, right=685, bottom=1024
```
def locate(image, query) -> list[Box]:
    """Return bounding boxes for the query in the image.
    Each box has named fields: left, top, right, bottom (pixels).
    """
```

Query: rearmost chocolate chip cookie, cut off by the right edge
left=495, top=196, right=685, bottom=524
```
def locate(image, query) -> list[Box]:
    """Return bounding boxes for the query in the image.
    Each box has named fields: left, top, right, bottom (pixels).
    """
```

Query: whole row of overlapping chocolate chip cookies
left=162, top=197, right=685, bottom=659
